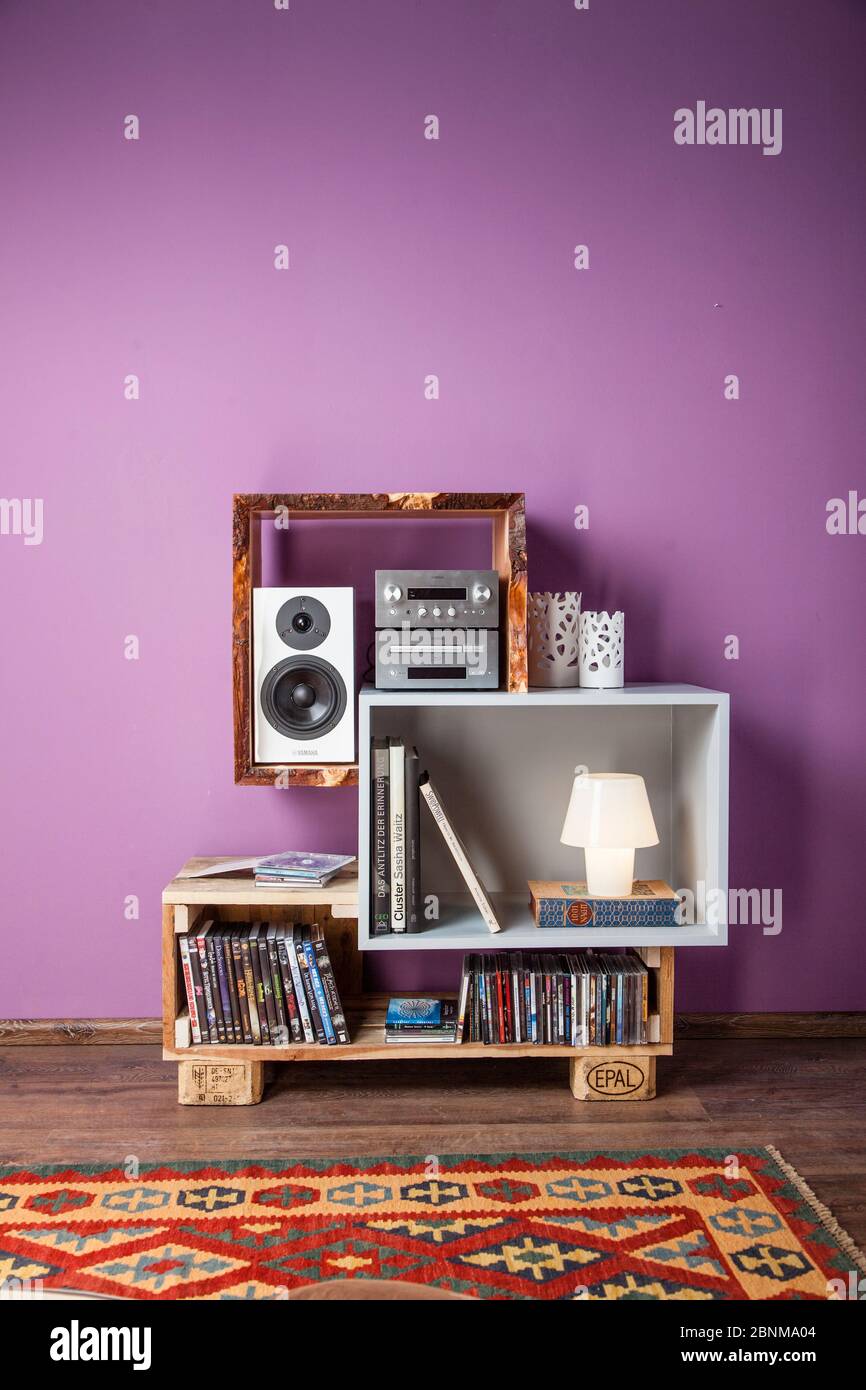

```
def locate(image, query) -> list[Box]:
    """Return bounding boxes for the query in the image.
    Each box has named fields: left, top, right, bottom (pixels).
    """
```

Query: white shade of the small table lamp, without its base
left=560, top=773, right=659, bottom=849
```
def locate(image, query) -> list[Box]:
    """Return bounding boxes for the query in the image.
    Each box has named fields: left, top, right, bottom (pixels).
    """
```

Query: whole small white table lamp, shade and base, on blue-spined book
left=560, top=773, right=659, bottom=898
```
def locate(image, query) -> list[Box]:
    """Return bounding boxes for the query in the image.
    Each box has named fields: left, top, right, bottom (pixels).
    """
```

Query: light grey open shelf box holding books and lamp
left=359, top=685, right=728, bottom=951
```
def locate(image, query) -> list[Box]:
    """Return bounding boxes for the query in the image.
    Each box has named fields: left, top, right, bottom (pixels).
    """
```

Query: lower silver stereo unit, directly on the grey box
left=375, top=627, right=499, bottom=691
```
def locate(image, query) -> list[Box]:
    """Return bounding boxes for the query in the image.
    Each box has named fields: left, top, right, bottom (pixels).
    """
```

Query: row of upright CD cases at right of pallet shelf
left=457, top=951, right=657, bottom=1047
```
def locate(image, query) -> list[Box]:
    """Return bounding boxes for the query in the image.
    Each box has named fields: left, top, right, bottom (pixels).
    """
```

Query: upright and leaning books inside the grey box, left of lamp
left=370, top=738, right=502, bottom=937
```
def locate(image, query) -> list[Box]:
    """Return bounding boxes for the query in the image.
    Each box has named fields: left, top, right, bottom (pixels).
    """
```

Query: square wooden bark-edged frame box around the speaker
left=232, top=492, right=528, bottom=787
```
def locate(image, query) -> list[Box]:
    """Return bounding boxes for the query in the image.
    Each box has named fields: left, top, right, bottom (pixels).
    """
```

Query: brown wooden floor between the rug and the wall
left=0, top=1038, right=866, bottom=1248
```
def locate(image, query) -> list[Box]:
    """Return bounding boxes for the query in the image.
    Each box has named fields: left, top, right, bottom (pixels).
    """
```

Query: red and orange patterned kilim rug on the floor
left=0, top=1148, right=866, bottom=1300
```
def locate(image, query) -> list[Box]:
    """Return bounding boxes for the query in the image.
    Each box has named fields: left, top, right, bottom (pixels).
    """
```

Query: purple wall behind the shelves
left=0, top=0, right=866, bottom=1016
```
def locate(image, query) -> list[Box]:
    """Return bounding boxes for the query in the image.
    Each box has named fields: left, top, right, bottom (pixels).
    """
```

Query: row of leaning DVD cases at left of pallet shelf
left=178, top=922, right=349, bottom=1047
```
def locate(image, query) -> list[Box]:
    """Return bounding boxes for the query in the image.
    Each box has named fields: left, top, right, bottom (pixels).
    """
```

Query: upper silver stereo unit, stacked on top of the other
left=375, top=570, right=499, bottom=628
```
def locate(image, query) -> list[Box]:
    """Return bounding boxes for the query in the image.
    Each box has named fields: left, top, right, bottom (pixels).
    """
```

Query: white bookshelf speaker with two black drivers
left=253, top=588, right=354, bottom=763
